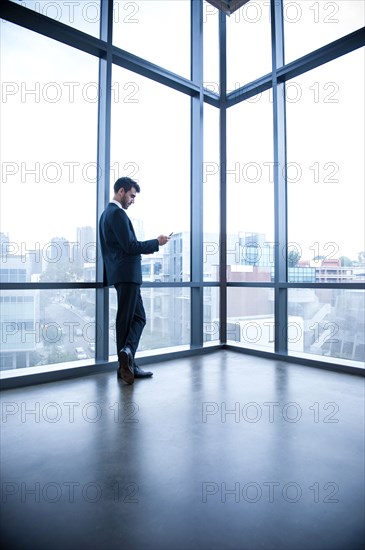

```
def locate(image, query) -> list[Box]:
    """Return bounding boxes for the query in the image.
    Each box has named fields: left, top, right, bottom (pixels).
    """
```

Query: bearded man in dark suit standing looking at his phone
left=99, top=177, right=169, bottom=384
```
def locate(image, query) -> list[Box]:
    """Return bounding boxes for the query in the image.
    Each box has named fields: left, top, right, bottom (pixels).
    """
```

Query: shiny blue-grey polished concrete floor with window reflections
left=1, top=351, right=365, bottom=550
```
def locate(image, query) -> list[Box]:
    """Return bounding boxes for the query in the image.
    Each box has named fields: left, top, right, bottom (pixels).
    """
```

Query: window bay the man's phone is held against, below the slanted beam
left=110, top=67, right=190, bottom=355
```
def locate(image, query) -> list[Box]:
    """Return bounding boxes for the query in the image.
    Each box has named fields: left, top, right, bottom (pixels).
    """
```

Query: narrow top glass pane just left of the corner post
left=203, top=2, right=219, bottom=94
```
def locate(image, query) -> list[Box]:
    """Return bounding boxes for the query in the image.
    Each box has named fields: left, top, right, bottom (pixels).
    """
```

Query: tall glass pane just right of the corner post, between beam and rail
left=227, top=92, right=274, bottom=282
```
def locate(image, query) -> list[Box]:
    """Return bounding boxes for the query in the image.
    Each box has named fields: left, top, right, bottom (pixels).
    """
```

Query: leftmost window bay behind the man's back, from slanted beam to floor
left=0, top=17, right=98, bottom=369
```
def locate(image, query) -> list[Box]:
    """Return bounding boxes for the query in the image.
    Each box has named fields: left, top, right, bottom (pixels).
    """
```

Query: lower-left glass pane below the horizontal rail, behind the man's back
left=0, top=289, right=97, bottom=376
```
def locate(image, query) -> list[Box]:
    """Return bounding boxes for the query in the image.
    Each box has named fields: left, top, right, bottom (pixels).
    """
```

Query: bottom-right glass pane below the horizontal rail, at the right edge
left=288, top=288, right=365, bottom=367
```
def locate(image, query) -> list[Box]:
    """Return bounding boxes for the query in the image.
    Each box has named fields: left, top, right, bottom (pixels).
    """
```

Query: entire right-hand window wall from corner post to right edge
left=226, top=1, right=365, bottom=366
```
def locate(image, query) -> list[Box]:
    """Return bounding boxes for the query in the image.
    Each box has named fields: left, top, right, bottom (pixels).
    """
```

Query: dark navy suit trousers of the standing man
left=114, top=283, right=146, bottom=357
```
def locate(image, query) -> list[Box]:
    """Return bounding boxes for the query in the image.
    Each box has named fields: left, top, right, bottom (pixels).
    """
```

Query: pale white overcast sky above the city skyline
left=0, top=0, right=365, bottom=264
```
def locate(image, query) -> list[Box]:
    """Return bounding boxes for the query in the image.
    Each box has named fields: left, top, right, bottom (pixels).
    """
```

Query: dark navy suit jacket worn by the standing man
left=99, top=202, right=159, bottom=286
